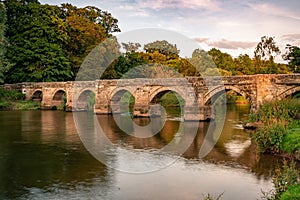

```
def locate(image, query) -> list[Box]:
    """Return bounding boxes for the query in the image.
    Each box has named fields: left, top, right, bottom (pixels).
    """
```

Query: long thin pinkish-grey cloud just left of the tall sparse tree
left=194, top=38, right=256, bottom=50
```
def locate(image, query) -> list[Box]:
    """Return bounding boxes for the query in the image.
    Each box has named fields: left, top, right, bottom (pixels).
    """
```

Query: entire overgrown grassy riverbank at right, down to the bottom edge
left=248, top=99, right=300, bottom=200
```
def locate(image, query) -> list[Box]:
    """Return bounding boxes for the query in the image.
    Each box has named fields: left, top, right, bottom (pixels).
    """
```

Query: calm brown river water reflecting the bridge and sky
left=0, top=106, right=280, bottom=200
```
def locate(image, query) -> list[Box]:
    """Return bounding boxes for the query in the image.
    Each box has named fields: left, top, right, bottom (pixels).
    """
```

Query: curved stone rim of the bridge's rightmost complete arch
left=204, top=85, right=252, bottom=105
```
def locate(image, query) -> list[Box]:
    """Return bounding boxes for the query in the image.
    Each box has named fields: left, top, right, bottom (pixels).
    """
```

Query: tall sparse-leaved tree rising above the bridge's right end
left=254, top=36, right=280, bottom=74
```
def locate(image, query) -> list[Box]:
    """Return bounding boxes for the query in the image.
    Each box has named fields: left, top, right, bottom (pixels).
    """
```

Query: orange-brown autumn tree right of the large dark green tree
left=61, top=4, right=120, bottom=75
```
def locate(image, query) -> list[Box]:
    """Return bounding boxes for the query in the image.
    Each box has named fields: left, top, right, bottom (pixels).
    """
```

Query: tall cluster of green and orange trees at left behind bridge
left=0, top=0, right=120, bottom=83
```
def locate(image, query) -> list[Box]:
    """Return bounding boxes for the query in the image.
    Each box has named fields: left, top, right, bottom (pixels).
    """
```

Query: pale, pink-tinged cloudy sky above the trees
left=40, top=0, right=300, bottom=62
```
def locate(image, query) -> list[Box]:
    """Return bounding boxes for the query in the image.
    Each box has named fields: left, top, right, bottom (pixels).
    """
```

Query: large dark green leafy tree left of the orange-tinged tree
left=6, top=1, right=72, bottom=82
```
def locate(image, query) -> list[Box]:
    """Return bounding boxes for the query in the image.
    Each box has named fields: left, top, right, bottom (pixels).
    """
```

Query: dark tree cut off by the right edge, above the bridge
left=282, top=44, right=300, bottom=73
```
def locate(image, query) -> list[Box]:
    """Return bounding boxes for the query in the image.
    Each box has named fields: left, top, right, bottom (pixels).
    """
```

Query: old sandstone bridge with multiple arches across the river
left=4, top=74, right=300, bottom=120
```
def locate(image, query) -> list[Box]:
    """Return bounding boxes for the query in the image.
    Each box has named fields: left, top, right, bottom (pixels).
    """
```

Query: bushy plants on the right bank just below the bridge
left=251, top=99, right=300, bottom=153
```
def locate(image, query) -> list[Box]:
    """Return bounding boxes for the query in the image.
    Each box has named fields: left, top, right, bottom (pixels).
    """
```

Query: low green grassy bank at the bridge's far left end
left=0, top=88, right=40, bottom=110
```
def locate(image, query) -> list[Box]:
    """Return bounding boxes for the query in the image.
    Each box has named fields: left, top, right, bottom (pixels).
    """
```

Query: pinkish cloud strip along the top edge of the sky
left=137, top=0, right=221, bottom=11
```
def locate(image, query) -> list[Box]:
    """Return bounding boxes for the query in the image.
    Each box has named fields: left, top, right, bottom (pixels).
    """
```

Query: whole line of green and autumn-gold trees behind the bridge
left=0, top=0, right=300, bottom=83
